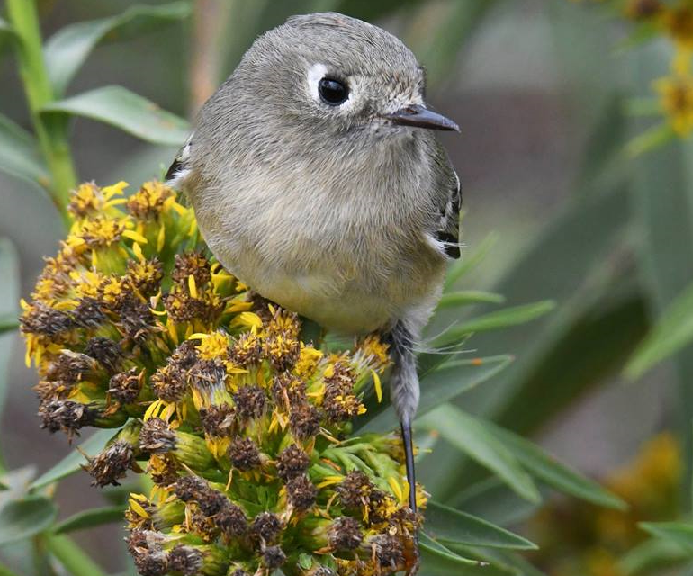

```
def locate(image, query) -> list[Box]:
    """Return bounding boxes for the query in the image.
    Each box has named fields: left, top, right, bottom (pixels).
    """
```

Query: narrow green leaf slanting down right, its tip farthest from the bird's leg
left=470, top=416, right=627, bottom=510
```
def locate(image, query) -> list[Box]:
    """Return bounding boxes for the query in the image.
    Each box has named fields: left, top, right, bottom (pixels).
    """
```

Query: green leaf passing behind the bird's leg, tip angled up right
left=354, top=356, right=512, bottom=432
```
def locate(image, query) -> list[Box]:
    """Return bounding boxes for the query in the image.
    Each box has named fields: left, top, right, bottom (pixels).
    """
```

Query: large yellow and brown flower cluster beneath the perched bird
left=21, top=182, right=425, bottom=576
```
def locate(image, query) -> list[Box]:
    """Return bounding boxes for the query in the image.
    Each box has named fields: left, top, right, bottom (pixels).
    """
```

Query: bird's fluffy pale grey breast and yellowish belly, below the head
left=192, top=146, right=444, bottom=333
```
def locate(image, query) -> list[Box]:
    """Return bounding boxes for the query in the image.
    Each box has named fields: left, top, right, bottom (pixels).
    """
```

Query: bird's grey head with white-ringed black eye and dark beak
left=227, top=13, right=459, bottom=142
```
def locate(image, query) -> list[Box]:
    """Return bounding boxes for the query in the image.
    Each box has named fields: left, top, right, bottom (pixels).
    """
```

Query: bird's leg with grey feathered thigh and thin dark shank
left=387, top=320, right=419, bottom=575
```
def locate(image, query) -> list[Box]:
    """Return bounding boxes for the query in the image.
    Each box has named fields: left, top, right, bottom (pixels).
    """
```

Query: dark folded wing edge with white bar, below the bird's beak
left=434, top=143, right=462, bottom=258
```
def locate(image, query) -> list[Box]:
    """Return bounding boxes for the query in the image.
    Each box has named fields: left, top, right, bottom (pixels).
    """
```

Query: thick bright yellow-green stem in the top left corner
left=5, top=0, right=77, bottom=224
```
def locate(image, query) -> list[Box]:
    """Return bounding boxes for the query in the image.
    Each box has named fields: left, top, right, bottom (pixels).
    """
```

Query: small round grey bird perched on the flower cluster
left=166, top=7, right=461, bottom=532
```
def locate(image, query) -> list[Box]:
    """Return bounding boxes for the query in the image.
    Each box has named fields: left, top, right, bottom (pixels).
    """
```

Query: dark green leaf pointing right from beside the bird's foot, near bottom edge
left=425, top=500, right=536, bottom=550
